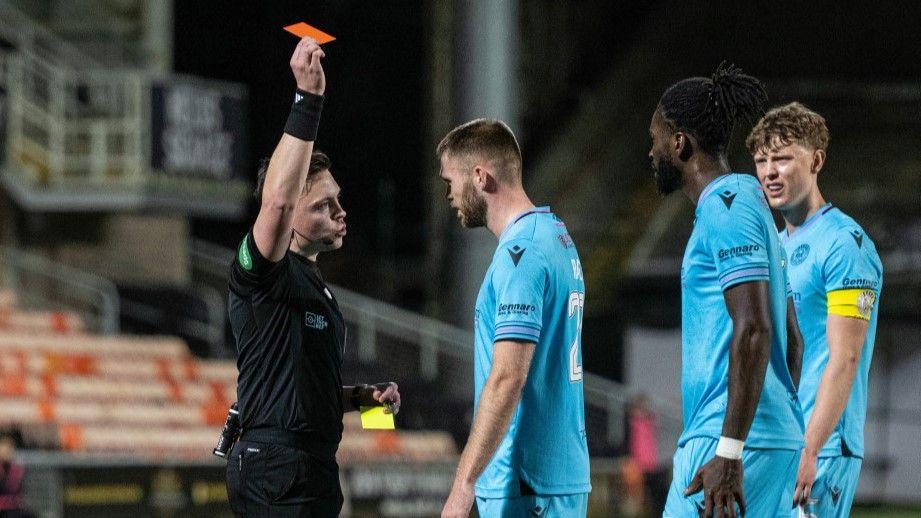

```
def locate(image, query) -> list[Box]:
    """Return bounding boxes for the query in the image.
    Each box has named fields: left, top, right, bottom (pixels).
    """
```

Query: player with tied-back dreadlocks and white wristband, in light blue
left=649, top=65, right=803, bottom=518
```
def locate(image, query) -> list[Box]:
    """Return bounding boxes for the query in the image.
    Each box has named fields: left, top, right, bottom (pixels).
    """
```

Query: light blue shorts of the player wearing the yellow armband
left=790, top=456, right=863, bottom=518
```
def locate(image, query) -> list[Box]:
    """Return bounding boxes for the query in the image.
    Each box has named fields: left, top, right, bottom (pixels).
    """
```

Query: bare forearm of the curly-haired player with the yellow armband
left=806, top=355, right=859, bottom=455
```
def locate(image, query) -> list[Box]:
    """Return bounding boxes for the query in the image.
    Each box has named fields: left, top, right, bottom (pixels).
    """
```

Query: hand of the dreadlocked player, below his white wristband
left=684, top=456, right=745, bottom=518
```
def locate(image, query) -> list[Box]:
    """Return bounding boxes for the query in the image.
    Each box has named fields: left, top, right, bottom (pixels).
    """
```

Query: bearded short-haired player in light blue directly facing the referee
left=437, top=119, right=591, bottom=518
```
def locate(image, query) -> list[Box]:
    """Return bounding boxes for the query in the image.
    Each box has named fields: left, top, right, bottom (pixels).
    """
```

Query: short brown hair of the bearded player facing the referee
left=435, top=119, right=521, bottom=183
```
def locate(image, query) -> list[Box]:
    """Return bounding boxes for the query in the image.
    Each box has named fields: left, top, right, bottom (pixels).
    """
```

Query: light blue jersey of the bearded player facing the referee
left=474, top=207, right=591, bottom=498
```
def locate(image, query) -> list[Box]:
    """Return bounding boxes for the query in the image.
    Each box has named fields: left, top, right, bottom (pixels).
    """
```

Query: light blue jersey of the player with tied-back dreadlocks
left=678, top=174, right=803, bottom=450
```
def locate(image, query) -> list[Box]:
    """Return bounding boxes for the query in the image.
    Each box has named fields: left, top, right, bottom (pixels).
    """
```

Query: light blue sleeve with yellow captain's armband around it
left=822, top=227, right=883, bottom=320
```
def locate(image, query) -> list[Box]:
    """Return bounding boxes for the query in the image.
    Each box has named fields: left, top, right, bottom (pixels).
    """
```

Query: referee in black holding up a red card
left=227, top=38, right=400, bottom=518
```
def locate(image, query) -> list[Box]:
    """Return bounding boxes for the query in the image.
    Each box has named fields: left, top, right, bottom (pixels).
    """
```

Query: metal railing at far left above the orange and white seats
left=0, top=246, right=119, bottom=335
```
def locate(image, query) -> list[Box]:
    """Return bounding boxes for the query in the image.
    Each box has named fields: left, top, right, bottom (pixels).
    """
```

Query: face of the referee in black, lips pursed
left=292, top=170, right=346, bottom=253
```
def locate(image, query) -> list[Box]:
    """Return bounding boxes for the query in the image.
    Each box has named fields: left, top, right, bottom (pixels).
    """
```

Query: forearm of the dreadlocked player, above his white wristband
left=722, top=321, right=771, bottom=441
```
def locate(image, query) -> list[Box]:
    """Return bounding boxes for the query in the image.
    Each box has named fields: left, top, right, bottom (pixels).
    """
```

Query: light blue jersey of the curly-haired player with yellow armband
left=780, top=204, right=883, bottom=458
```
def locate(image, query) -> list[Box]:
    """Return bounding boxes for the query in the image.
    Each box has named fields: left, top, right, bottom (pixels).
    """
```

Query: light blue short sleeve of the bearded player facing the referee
left=492, top=240, right=550, bottom=343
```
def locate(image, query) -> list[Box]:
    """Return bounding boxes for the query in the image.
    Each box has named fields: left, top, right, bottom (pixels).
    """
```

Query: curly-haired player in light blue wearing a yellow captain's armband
left=746, top=103, right=883, bottom=517
